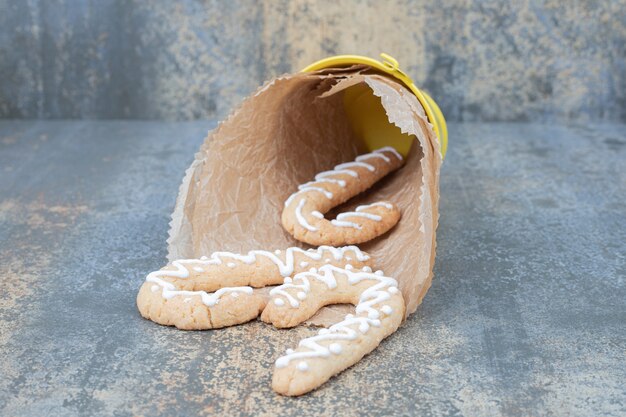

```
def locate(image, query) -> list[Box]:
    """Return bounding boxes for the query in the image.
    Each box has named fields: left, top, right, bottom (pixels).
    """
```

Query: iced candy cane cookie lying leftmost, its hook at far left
left=137, top=246, right=371, bottom=330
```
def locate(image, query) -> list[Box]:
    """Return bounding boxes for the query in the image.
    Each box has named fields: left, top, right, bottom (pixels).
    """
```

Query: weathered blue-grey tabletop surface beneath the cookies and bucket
left=0, top=121, right=626, bottom=416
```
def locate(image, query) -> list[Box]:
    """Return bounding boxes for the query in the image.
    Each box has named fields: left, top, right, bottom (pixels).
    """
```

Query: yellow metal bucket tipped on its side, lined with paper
left=302, top=54, right=448, bottom=157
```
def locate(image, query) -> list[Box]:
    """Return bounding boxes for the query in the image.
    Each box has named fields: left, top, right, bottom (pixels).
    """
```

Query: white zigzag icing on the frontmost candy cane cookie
left=270, top=265, right=398, bottom=369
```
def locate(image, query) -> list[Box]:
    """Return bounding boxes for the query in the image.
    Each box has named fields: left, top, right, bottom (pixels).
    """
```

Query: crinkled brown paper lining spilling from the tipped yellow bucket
left=168, top=66, right=441, bottom=325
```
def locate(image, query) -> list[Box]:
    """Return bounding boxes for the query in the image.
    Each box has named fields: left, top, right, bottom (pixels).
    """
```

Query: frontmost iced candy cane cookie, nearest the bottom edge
left=261, top=265, right=404, bottom=396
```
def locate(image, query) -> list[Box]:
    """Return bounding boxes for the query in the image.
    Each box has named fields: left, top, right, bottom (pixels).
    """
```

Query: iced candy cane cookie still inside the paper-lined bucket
left=282, top=146, right=404, bottom=246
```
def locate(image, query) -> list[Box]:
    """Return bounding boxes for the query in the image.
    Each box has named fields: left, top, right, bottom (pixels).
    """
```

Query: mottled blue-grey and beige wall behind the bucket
left=0, top=0, right=626, bottom=122
